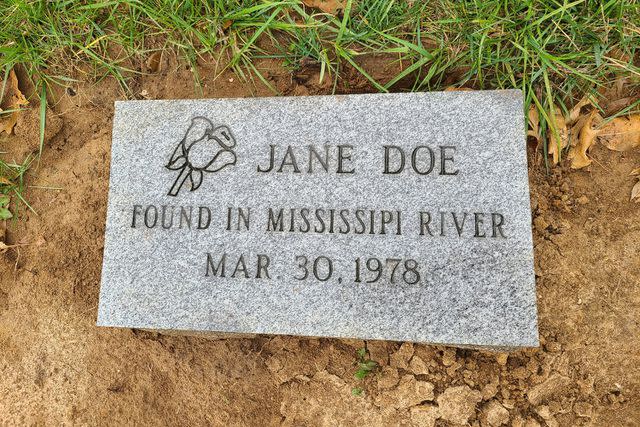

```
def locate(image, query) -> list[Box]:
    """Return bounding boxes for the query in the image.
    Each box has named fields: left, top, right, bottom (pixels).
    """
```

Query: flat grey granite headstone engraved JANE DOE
left=98, top=90, right=538, bottom=348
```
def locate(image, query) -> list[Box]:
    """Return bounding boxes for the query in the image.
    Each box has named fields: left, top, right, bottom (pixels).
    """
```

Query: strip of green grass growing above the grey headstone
left=0, top=0, right=640, bottom=217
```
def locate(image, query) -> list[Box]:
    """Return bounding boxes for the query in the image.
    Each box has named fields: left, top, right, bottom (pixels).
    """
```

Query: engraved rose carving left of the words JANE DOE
left=166, top=116, right=236, bottom=196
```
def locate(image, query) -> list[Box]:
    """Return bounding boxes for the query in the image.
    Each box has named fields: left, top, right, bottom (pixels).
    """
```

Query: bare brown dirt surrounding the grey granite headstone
left=0, top=58, right=640, bottom=427
